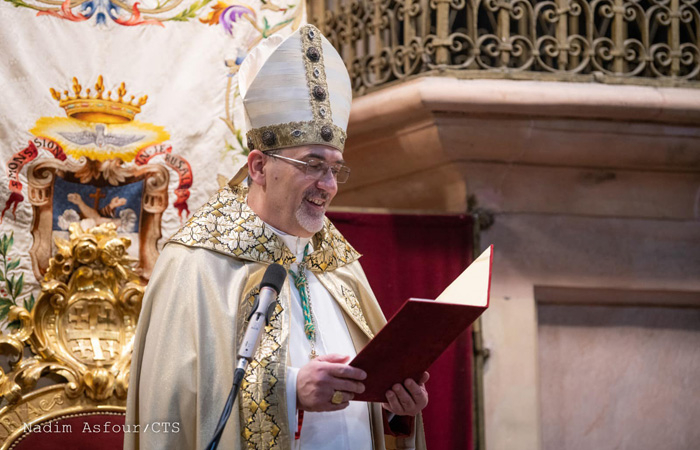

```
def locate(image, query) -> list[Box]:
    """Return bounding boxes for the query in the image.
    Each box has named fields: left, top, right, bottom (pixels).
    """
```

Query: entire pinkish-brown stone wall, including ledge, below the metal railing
left=334, top=78, right=700, bottom=450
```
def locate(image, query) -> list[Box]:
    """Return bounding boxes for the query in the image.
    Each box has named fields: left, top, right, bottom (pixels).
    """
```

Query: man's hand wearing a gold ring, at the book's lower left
left=297, top=354, right=367, bottom=411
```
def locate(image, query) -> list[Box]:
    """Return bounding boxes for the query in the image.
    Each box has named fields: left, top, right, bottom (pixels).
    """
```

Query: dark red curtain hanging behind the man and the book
left=328, top=212, right=474, bottom=450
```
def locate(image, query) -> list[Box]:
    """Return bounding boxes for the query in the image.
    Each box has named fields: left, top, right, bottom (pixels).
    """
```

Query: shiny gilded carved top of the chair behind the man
left=0, top=223, right=143, bottom=438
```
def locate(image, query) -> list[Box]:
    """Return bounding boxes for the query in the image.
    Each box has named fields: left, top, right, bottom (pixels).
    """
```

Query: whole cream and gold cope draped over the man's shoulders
left=125, top=185, right=425, bottom=450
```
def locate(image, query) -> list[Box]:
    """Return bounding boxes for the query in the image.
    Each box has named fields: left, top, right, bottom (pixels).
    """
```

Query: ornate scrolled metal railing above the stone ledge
left=309, top=0, right=700, bottom=94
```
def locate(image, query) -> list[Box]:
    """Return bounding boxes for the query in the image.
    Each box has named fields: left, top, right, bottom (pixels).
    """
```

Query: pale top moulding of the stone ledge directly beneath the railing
left=348, top=77, right=700, bottom=136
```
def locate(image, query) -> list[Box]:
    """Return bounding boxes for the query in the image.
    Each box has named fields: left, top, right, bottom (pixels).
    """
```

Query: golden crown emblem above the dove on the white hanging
left=51, top=75, right=148, bottom=123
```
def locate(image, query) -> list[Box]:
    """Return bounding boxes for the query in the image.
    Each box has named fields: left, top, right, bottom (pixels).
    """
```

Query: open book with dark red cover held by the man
left=350, top=246, right=493, bottom=402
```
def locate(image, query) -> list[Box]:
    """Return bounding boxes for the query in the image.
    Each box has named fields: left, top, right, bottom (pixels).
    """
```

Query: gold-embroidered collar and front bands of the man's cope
left=169, top=185, right=383, bottom=449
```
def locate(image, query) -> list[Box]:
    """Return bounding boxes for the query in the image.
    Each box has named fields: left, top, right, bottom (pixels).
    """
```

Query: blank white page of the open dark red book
left=435, top=245, right=493, bottom=306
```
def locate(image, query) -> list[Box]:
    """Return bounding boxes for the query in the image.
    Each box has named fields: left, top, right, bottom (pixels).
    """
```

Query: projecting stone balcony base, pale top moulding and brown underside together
left=334, top=77, right=700, bottom=220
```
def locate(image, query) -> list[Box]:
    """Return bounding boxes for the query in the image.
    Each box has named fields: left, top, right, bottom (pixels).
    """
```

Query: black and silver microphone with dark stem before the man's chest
left=206, top=264, right=287, bottom=450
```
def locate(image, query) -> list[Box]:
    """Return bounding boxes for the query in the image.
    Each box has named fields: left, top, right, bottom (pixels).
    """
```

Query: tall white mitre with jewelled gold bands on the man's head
left=238, top=25, right=352, bottom=152
